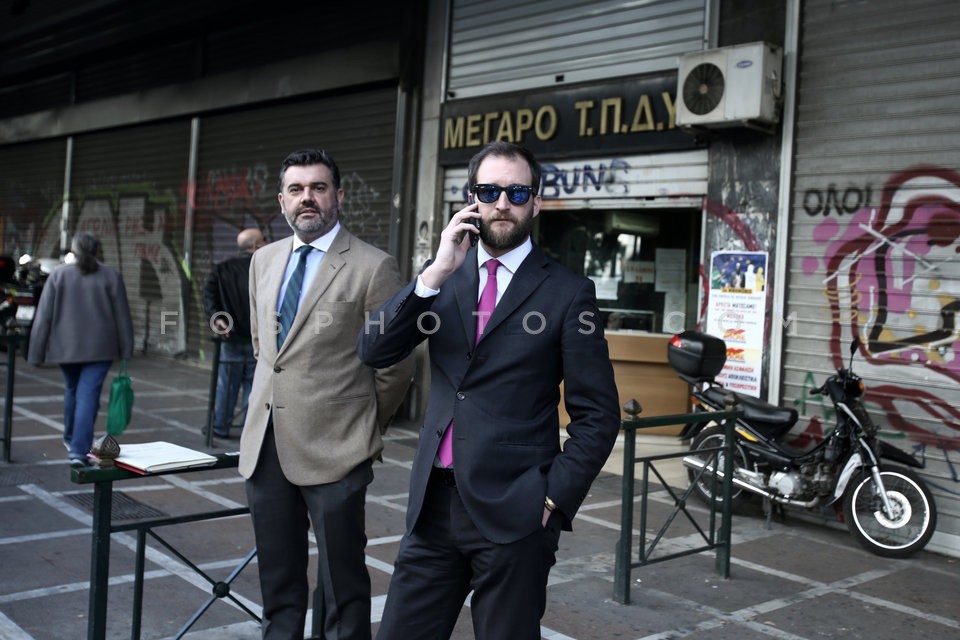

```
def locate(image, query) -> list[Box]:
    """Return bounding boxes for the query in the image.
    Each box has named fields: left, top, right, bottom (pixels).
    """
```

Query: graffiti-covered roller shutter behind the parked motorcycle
left=783, top=0, right=960, bottom=554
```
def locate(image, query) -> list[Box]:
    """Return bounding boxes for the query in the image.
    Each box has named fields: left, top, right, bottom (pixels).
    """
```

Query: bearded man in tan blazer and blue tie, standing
left=240, top=149, right=413, bottom=640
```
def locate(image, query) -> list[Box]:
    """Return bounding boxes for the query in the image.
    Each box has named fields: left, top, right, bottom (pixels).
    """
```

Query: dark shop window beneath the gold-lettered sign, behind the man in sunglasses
left=535, top=209, right=700, bottom=333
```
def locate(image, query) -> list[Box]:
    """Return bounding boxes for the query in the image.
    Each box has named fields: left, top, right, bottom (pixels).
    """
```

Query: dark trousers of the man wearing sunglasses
left=377, top=471, right=560, bottom=640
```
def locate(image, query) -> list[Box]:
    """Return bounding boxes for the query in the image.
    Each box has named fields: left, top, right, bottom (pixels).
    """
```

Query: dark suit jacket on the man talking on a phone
left=357, top=247, right=620, bottom=544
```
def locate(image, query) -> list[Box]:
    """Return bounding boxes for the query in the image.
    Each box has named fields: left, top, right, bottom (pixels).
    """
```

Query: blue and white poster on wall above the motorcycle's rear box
left=707, top=251, right=767, bottom=398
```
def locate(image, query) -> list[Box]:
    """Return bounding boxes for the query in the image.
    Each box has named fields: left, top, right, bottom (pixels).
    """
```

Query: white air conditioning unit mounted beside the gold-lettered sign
left=676, top=42, right=783, bottom=130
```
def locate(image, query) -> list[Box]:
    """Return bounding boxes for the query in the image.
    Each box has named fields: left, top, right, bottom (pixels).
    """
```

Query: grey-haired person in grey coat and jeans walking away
left=27, top=231, right=133, bottom=466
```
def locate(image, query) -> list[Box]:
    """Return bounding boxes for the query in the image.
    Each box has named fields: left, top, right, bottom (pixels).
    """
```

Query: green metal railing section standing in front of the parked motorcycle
left=613, top=400, right=742, bottom=604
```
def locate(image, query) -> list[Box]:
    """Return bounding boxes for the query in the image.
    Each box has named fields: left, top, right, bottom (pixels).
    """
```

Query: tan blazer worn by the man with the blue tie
left=240, top=227, right=413, bottom=485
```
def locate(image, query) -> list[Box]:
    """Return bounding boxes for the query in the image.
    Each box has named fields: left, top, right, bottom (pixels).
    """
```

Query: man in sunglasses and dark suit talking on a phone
left=357, top=142, right=620, bottom=640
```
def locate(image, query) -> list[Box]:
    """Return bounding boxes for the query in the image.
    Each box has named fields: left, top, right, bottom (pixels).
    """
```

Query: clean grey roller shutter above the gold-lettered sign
left=446, top=0, right=706, bottom=99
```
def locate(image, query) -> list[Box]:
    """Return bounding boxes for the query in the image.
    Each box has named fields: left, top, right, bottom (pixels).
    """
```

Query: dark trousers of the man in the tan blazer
left=246, top=425, right=373, bottom=640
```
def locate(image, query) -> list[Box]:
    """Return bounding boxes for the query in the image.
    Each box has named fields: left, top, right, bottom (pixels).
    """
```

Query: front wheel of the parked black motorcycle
left=843, top=466, right=937, bottom=558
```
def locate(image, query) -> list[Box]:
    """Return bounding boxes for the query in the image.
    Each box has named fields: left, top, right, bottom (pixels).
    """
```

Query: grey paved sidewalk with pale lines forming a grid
left=0, top=357, right=960, bottom=640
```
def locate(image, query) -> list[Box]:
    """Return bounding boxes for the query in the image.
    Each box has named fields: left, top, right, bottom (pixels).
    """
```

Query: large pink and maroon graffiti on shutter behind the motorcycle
left=803, top=166, right=960, bottom=472
